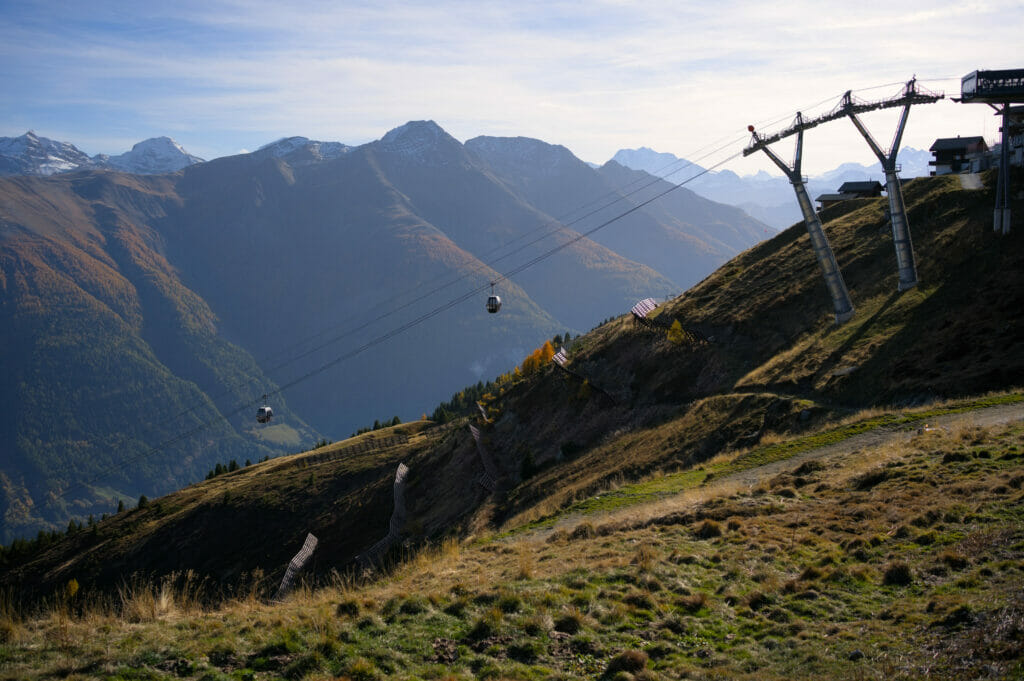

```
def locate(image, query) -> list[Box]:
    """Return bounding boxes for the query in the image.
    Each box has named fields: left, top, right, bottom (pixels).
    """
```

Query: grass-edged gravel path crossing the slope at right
left=519, top=402, right=1024, bottom=541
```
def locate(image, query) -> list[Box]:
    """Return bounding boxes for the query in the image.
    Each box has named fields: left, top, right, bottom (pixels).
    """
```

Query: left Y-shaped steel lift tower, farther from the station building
left=743, top=112, right=853, bottom=324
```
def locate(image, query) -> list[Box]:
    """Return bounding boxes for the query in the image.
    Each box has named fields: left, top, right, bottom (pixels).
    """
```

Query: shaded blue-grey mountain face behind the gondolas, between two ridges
left=162, top=147, right=564, bottom=436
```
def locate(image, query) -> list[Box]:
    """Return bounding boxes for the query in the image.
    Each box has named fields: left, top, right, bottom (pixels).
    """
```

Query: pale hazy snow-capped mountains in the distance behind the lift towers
left=612, top=146, right=931, bottom=228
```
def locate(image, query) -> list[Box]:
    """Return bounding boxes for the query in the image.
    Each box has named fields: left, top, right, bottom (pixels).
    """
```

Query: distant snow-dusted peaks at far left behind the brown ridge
left=0, top=130, right=203, bottom=175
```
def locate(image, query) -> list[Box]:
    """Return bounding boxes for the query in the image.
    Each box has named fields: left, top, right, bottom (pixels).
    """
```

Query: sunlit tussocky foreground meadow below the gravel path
left=0, top=409, right=1024, bottom=679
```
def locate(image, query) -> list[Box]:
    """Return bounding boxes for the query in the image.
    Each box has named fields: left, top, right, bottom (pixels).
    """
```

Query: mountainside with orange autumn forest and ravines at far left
left=0, top=175, right=313, bottom=541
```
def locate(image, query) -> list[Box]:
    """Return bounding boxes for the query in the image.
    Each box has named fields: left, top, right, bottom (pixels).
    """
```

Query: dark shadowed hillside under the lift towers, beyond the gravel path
left=3, top=168, right=1024, bottom=602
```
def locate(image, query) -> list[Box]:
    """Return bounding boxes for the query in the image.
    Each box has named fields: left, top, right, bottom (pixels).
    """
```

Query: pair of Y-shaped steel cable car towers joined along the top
left=743, top=78, right=944, bottom=315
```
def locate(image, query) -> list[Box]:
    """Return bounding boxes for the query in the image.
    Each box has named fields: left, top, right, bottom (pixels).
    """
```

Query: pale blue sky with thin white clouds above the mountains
left=0, top=0, right=1024, bottom=174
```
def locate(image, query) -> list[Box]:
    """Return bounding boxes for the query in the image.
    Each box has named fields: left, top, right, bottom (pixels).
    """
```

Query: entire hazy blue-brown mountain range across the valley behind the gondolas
left=0, top=121, right=765, bottom=541
